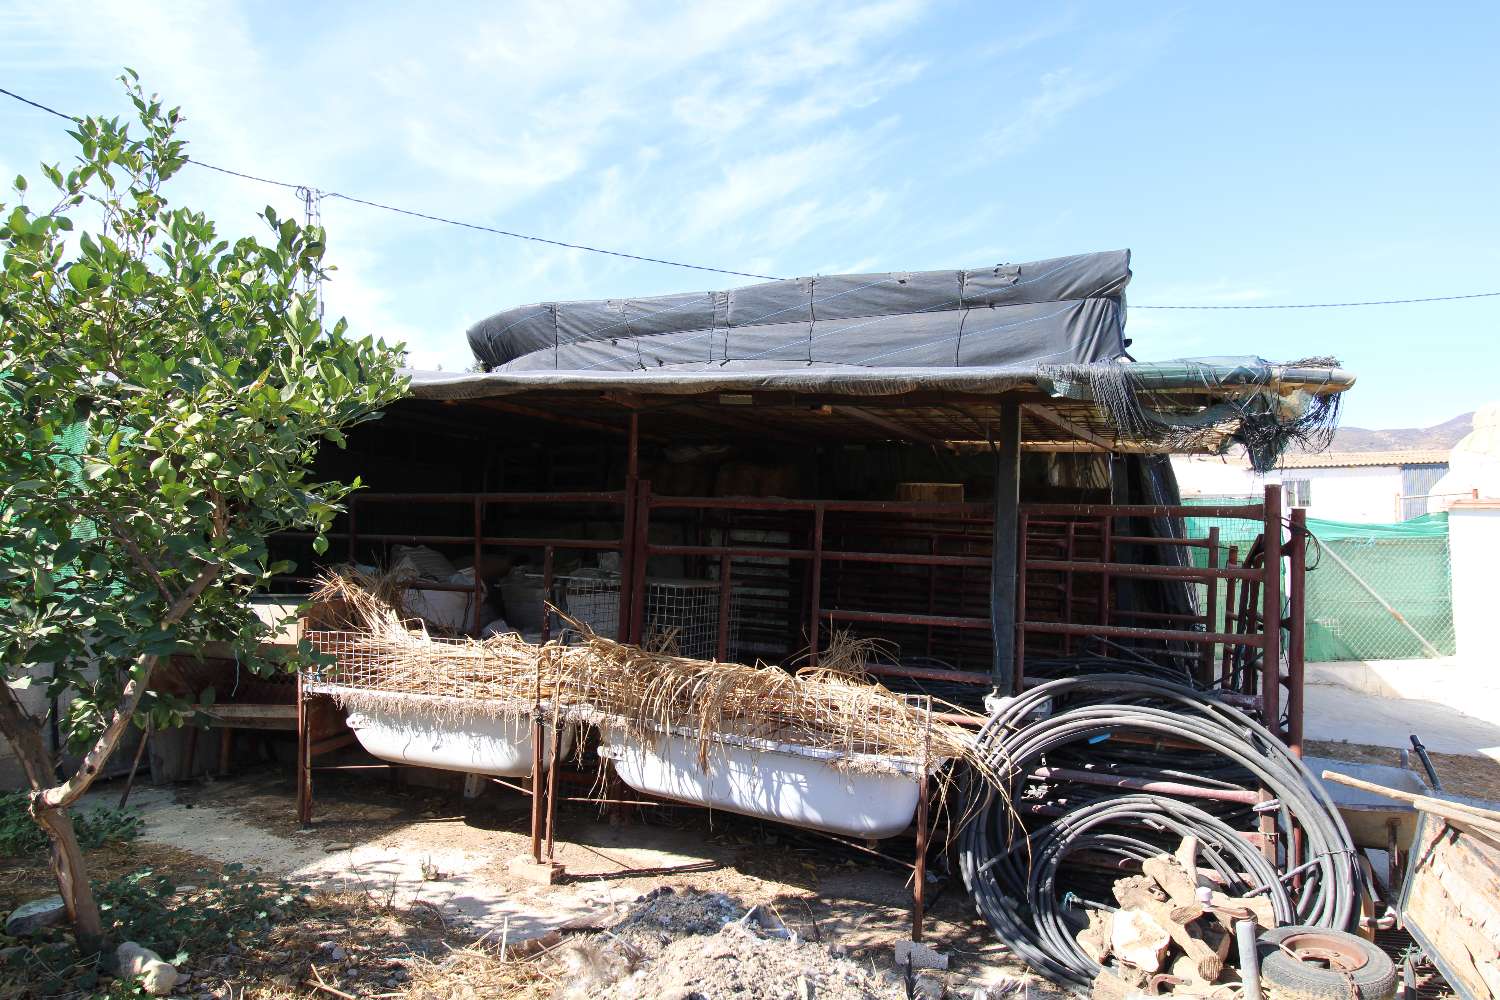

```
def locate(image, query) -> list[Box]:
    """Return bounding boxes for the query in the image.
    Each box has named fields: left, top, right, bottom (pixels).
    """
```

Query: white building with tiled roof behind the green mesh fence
left=1172, top=448, right=1448, bottom=523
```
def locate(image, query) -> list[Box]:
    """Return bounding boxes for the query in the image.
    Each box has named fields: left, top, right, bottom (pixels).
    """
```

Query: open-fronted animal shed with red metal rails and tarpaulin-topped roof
left=276, top=250, right=1353, bottom=739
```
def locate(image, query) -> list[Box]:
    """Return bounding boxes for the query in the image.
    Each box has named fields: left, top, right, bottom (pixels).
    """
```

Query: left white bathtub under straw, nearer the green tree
left=314, top=685, right=575, bottom=778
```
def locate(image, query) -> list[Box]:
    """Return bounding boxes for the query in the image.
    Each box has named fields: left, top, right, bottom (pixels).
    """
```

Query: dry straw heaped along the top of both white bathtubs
left=309, top=576, right=996, bottom=766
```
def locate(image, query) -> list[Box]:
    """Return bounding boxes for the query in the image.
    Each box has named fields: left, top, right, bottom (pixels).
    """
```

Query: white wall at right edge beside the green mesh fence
left=1448, top=499, right=1500, bottom=687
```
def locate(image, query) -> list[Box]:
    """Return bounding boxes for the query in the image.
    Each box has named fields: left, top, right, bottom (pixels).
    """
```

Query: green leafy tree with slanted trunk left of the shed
left=0, top=70, right=405, bottom=951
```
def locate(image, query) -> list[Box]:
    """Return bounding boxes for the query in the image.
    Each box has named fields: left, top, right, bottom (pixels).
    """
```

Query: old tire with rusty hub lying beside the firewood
left=1257, top=927, right=1397, bottom=1000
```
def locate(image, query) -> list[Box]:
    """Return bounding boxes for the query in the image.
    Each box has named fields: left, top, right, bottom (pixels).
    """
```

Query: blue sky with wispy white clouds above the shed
left=0, top=0, right=1500, bottom=427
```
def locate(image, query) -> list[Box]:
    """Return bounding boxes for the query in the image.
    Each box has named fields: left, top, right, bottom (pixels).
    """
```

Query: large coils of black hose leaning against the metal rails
left=959, top=676, right=1359, bottom=993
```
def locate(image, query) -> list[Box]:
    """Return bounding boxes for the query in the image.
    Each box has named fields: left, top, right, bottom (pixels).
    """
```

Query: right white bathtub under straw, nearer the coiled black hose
left=599, top=726, right=941, bottom=840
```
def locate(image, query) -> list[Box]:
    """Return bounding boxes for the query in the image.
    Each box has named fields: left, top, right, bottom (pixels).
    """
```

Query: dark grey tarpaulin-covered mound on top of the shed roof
left=468, top=250, right=1131, bottom=379
